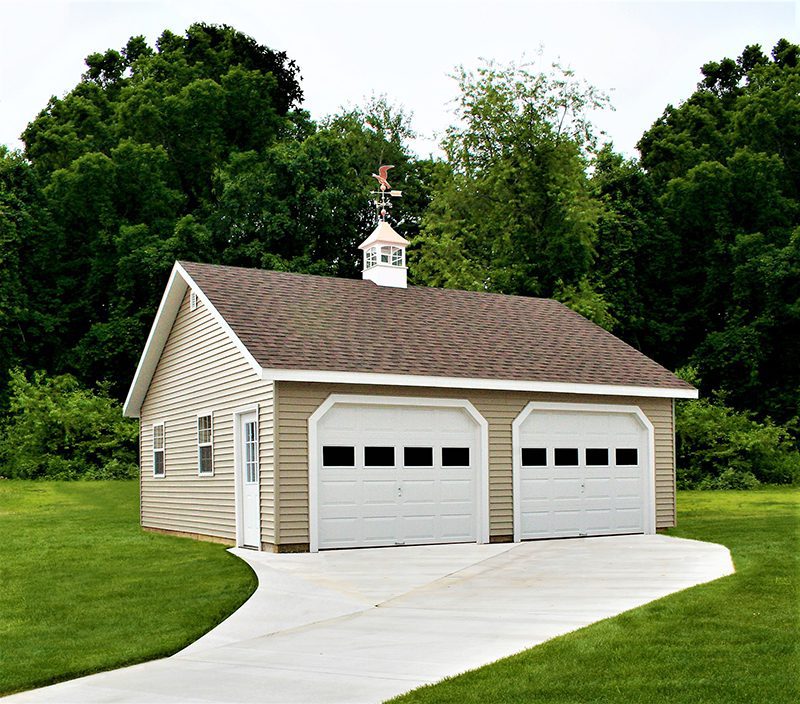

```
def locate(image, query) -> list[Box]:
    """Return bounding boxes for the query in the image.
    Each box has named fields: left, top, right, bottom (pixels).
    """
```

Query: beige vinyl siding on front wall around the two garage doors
left=275, top=382, right=675, bottom=545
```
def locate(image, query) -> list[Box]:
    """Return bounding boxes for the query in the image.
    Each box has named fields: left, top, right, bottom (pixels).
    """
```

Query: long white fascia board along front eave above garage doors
left=261, top=369, right=698, bottom=398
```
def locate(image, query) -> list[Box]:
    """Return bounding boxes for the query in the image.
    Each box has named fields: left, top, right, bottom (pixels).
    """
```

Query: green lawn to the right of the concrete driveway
left=392, top=487, right=800, bottom=704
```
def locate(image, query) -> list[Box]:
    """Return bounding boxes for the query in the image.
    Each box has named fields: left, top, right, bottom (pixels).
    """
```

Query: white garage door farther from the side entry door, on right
left=515, top=404, right=651, bottom=540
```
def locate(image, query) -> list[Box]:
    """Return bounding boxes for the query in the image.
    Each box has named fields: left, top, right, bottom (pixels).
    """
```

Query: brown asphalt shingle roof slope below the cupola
left=181, top=262, right=693, bottom=389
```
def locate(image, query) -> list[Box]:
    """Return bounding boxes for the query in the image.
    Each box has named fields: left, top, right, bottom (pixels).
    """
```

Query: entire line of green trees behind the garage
left=0, top=24, right=800, bottom=484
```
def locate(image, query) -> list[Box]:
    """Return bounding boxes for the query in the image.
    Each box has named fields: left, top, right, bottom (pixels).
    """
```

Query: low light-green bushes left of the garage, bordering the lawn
left=0, top=370, right=138, bottom=479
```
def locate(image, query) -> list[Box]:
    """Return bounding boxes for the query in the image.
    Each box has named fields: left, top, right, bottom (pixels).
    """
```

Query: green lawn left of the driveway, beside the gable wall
left=0, top=480, right=256, bottom=695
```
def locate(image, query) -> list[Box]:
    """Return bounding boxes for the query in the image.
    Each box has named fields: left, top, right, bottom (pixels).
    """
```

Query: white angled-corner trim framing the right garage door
left=511, top=401, right=656, bottom=542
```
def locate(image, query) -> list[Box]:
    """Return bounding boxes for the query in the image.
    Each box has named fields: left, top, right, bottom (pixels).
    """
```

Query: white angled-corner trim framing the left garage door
left=308, top=394, right=489, bottom=552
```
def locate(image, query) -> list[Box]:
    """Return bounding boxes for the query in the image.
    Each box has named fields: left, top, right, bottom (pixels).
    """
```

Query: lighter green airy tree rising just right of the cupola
left=412, top=63, right=606, bottom=312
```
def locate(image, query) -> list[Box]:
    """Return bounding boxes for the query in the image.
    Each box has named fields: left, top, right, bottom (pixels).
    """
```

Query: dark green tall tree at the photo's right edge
left=632, top=40, right=800, bottom=422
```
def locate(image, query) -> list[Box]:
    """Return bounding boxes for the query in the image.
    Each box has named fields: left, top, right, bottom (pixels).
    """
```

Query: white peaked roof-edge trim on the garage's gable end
left=122, top=262, right=262, bottom=418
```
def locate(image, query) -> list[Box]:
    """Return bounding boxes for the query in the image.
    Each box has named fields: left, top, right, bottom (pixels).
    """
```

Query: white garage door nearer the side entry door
left=316, top=404, right=480, bottom=549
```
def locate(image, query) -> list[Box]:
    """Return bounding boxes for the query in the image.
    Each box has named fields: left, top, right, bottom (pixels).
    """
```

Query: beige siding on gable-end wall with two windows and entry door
left=140, top=291, right=275, bottom=543
